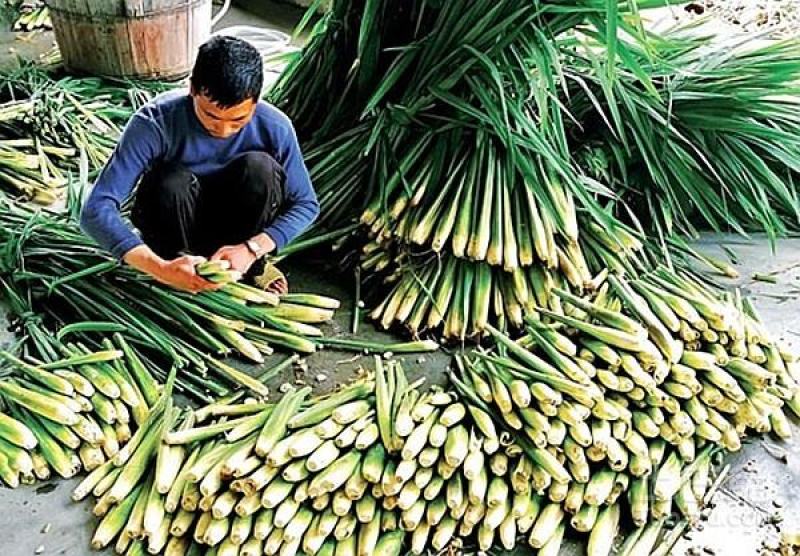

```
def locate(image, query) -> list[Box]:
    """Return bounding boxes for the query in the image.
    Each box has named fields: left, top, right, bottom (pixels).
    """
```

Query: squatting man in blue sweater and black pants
left=81, top=36, right=319, bottom=293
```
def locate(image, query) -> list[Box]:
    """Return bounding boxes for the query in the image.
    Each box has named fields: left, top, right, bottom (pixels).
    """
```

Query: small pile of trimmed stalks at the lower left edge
left=0, top=322, right=161, bottom=488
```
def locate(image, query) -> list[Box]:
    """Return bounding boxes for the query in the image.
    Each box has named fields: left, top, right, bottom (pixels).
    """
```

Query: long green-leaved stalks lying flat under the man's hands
left=0, top=194, right=350, bottom=399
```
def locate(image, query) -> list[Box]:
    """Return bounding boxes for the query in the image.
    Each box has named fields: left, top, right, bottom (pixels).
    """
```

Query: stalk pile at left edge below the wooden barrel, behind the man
left=0, top=63, right=165, bottom=205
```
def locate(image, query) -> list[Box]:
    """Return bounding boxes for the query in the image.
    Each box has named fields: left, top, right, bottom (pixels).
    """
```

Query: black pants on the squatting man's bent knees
left=131, top=152, right=286, bottom=259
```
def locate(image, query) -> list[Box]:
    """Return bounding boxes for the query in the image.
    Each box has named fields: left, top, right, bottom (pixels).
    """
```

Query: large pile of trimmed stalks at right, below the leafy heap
left=454, top=272, right=800, bottom=554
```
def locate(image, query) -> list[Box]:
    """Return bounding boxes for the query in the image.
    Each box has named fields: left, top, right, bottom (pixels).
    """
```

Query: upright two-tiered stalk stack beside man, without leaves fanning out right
left=273, top=2, right=635, bottom=338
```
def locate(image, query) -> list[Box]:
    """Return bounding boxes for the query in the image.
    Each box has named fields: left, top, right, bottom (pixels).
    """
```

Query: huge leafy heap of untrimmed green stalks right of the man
left=270, top=0, right=800, bottom=340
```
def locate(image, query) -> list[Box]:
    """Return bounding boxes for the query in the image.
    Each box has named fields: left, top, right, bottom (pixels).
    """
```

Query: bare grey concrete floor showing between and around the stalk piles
left=0, top=2, right=800, bottom=556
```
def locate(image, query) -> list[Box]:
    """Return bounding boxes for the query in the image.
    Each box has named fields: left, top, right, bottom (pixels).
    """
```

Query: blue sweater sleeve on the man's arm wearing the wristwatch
left=264, top=114, right=319, bottom=249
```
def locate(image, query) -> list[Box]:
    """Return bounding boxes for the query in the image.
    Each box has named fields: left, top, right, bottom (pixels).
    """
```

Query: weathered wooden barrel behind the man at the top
left=46, top=0, right=211, bottom=79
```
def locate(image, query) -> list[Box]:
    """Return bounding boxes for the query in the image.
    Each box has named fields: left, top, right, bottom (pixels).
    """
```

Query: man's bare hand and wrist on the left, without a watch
left=123, top=245, right=221, bottom=293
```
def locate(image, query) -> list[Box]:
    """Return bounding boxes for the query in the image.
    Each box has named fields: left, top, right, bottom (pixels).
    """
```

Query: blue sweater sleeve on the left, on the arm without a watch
left=81, top=112, right=163, bottom=258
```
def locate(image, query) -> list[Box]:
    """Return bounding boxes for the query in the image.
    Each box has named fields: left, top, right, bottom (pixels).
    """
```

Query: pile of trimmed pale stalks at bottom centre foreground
left=76, top=360, right=576, bottom=555
